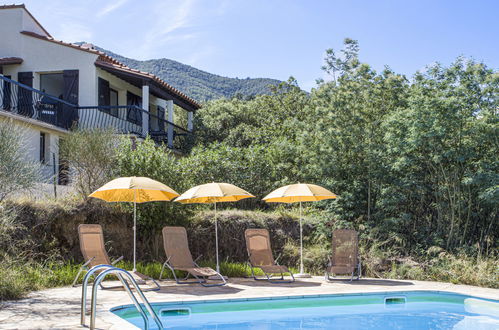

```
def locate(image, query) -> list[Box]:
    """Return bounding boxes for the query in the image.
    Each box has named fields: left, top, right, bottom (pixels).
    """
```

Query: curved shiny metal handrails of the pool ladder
left=81, top=265, right=163, bottom=330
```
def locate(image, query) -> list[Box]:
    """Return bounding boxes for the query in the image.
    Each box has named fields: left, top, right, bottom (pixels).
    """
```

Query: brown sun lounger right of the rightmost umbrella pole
left=325, top=229, right=362, bottom=281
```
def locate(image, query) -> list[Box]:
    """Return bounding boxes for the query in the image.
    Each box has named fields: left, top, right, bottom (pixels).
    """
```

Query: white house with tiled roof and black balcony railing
left=0, top=5, right=200, bottom=183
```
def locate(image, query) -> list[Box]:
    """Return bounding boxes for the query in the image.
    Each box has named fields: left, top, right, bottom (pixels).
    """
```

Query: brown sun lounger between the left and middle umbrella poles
left=159, top=226, right=226, bottom=286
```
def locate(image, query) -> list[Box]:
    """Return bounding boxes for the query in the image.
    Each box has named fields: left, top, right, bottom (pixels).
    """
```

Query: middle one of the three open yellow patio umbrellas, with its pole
left=175, top=182, right=255, bottom=272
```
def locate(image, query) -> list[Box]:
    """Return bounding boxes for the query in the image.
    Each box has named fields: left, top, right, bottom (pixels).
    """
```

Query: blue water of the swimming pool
left=111, top=291, right=499, bottom=330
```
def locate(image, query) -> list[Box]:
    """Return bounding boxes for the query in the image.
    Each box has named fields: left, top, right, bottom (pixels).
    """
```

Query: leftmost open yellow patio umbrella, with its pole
left=89, top=176, right=179, bottom=272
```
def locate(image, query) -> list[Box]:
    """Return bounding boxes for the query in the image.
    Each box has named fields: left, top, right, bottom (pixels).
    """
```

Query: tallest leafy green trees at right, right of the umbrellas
left=305, top=40, right=499, bottom=251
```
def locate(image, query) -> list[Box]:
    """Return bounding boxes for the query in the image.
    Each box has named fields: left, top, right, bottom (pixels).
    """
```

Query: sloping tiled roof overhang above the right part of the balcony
left=95, top=60, right=201, bottom=111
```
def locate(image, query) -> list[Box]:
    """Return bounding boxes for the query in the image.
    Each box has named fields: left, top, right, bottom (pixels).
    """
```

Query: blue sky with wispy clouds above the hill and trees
left=21, top=0, right=499, bottom=89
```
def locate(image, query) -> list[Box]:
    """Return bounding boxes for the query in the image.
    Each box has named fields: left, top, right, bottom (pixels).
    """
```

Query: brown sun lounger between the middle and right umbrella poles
left=244, top=229, right=295, bottom=283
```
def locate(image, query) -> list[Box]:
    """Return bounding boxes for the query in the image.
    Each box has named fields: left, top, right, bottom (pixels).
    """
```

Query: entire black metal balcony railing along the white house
left=0, top=75, right=192, bottom=151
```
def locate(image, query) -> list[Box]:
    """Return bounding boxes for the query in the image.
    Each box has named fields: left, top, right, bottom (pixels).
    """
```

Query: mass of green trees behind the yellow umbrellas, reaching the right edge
left=115, top=39, right=499, bottom=255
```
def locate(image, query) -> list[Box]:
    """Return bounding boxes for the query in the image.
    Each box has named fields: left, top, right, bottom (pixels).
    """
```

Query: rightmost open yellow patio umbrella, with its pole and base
left=263, top=183, right=336, bottom=277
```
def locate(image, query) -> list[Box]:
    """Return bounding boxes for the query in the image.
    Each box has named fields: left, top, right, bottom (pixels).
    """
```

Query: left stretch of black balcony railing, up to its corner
left=0, top=75, right=78, bottom=129
